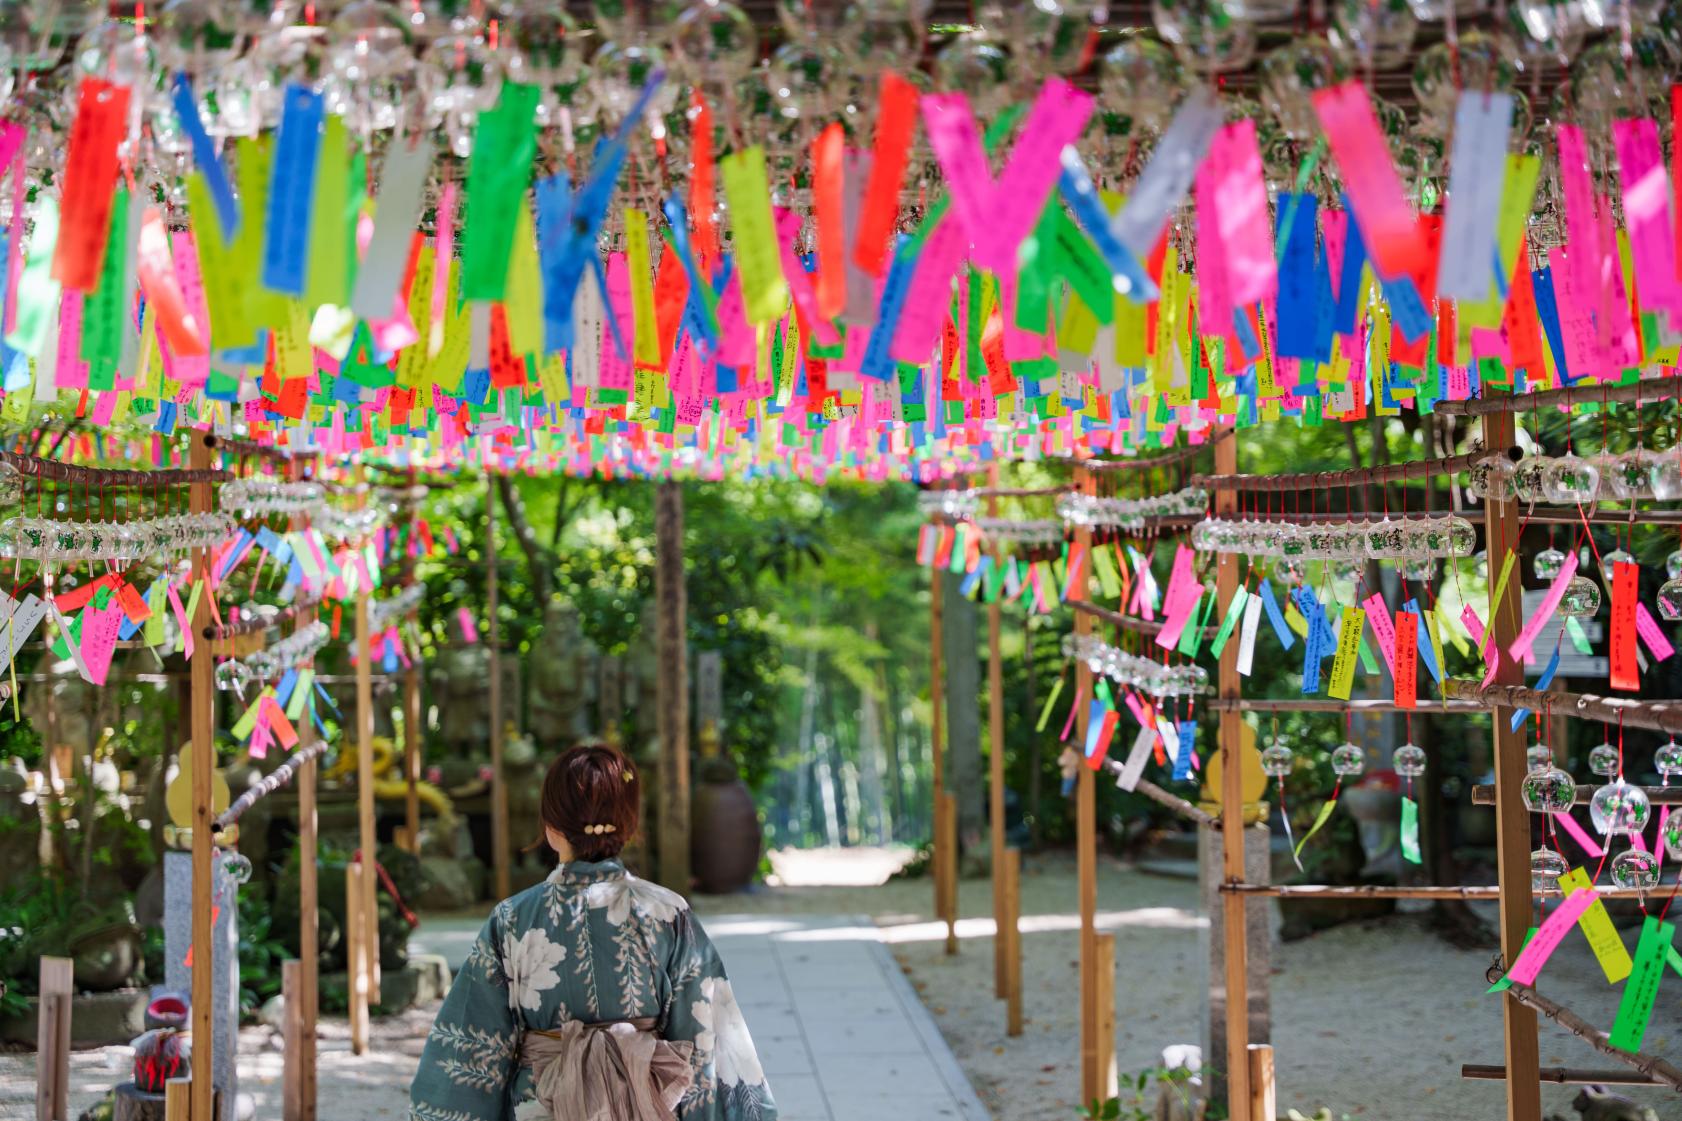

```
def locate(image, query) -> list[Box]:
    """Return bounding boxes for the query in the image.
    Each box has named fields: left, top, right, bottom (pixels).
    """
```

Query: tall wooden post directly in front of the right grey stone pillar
left=1214, top=431, right=1272, bottom=1121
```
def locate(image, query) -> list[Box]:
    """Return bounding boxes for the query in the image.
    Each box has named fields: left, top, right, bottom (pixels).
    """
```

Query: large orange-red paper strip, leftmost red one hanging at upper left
left=52, top=77, right=128, bottom=291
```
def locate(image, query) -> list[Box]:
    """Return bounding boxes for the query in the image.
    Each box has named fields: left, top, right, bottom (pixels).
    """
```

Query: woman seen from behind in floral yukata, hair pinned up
left=409, top=746, right=777, bottom=1121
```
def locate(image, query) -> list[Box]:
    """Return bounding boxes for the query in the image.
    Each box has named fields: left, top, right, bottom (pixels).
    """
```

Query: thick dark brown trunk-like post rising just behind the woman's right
left=654, top=480, right=690, bottom=892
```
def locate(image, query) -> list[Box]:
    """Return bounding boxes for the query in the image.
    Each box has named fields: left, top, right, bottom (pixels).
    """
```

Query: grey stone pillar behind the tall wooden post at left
left=163, top=852, right=239, bottom=1121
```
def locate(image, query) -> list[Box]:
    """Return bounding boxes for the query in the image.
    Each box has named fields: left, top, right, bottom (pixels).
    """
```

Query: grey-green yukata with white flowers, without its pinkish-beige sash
left=409, top=860, right=777, bottom=1121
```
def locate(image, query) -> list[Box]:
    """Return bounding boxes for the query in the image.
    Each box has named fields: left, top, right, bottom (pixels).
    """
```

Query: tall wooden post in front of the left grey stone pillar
left=187, top=433, right=215, bottom=1121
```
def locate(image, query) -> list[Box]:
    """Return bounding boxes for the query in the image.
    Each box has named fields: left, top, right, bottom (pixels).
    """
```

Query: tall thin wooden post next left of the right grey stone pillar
left=1068, top=466, right=1113, bottom=1104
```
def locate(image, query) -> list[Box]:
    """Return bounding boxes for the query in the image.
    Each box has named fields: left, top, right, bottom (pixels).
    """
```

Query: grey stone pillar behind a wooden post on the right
left=1198, top=825, right=1273, bottom=1101
